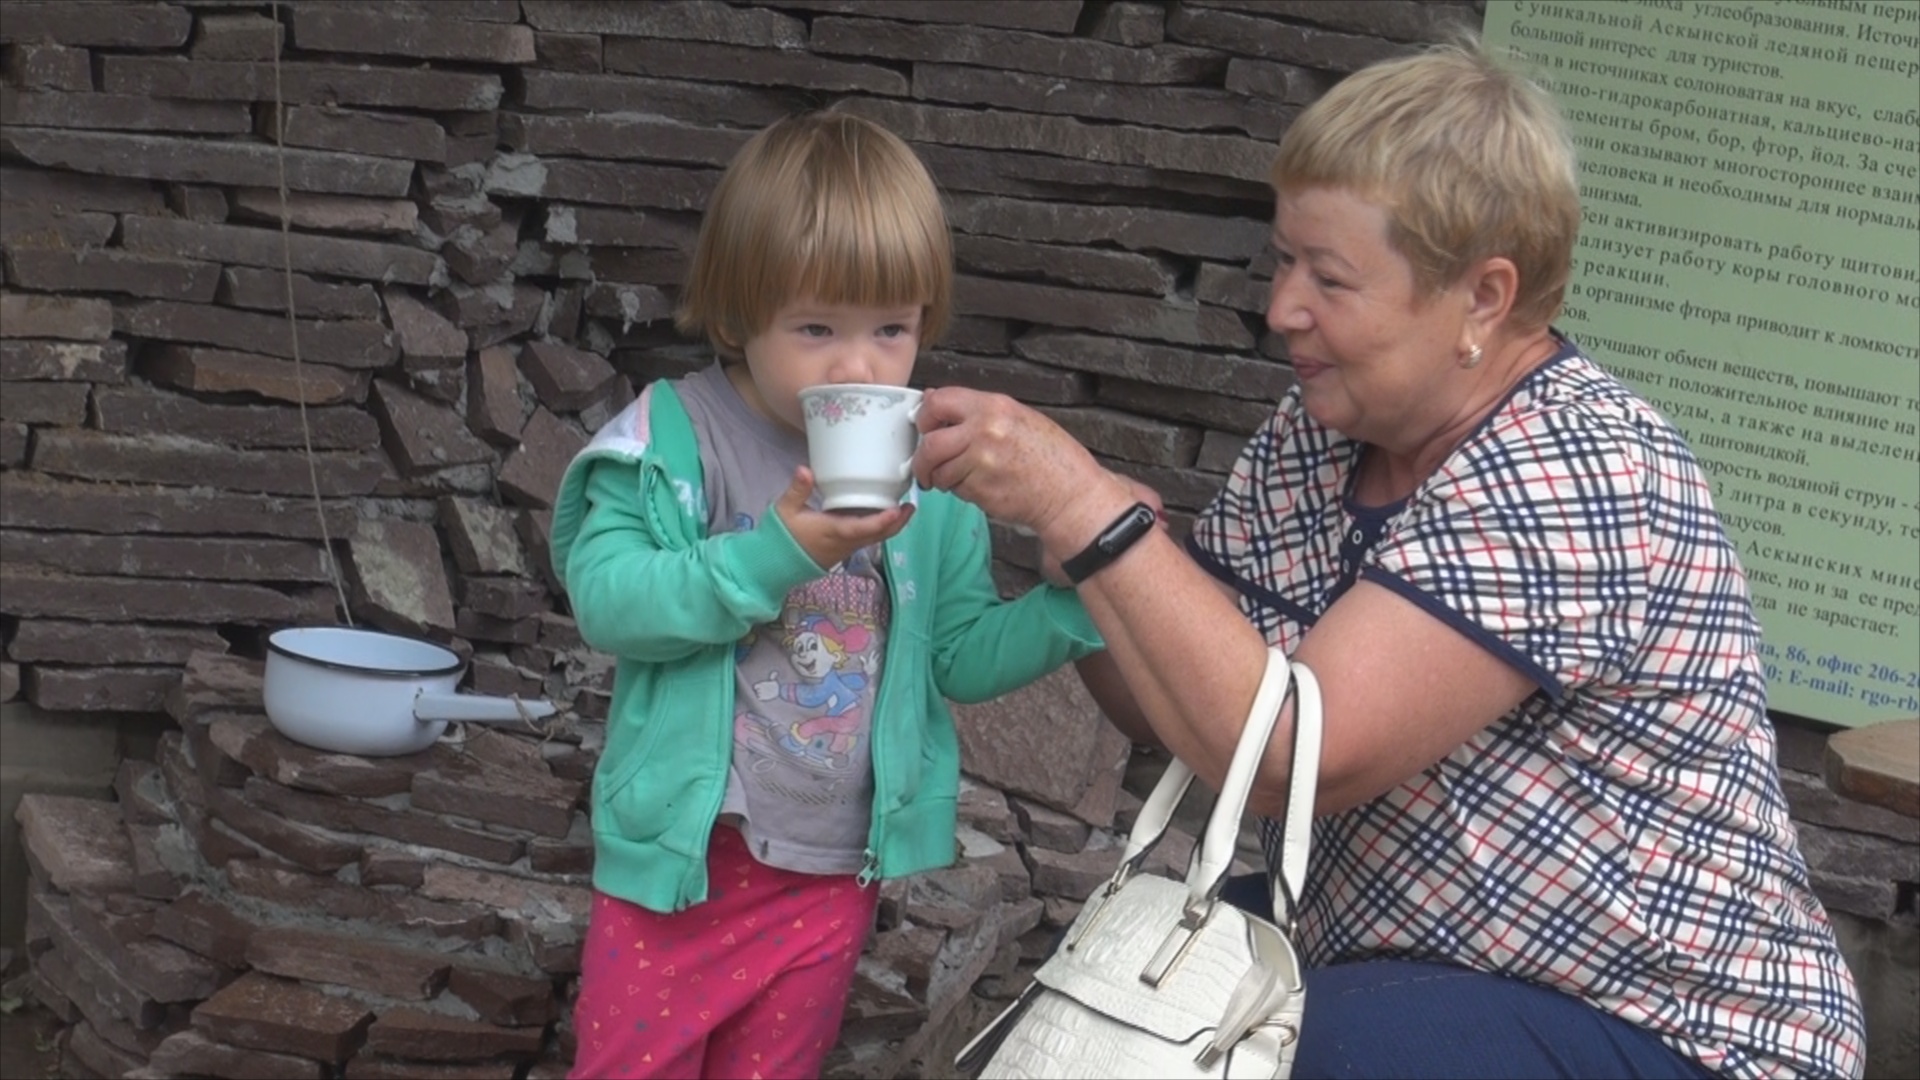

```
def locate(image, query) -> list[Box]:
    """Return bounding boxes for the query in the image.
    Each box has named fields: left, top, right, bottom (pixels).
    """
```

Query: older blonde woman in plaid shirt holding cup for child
left=918, top=46, right=1862, bottom=1076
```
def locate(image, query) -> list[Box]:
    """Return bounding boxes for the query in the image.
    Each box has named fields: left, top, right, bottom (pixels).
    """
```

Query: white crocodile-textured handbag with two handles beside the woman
left=956, top=650, right=1321, bottom=1080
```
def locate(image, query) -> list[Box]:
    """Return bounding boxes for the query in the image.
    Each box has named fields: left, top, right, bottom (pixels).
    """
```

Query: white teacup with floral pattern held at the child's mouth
left=801, top=382, right=920, bottom=511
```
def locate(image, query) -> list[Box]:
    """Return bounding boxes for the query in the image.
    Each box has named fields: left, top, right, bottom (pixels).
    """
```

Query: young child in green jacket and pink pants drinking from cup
left=553, top=113, right=1102, bottom=1076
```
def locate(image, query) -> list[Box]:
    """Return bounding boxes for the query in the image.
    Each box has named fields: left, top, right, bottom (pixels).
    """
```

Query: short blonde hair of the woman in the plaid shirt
left=1273, top=40, right=1580, bottom=329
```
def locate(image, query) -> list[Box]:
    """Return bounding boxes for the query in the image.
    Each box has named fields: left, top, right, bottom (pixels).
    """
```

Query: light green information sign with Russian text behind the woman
left=1484, top=0, right=1920, bottom=726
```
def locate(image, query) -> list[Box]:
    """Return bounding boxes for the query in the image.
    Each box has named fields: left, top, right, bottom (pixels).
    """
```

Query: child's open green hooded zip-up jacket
left=551, top=380, right=1104, bottom=913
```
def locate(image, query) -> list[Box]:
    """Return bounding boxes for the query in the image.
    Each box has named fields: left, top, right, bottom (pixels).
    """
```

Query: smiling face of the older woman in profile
left=1267, top=188, right=1467, bottom=450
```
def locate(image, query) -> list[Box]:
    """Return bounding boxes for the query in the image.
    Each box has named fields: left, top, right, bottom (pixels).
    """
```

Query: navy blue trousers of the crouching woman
left=1221, top=874, right=1713, bottom=1080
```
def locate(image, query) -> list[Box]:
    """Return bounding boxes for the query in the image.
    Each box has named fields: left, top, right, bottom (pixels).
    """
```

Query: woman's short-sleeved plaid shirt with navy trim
left=1188, top=344, right=1864, bottom=1076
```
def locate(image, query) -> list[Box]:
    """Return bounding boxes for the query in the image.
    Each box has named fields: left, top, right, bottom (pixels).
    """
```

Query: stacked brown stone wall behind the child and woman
left=0, top=0, right=1920, bottom=1078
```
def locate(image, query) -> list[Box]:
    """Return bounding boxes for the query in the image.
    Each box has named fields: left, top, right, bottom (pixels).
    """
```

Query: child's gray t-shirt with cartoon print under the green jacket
left=676, top=363, right=891, bottom=874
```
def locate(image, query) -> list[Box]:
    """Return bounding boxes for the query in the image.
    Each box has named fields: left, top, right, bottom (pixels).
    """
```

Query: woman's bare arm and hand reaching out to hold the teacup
left=920, top=388, right=1534, bottom=813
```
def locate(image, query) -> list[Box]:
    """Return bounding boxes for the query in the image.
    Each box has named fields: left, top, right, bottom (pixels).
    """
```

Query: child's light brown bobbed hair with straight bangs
left=674, top=111, right=954, bottom=359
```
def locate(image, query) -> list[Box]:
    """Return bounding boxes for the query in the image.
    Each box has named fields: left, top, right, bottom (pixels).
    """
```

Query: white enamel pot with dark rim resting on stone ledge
left=261, top=626, right=555, bottom=757
